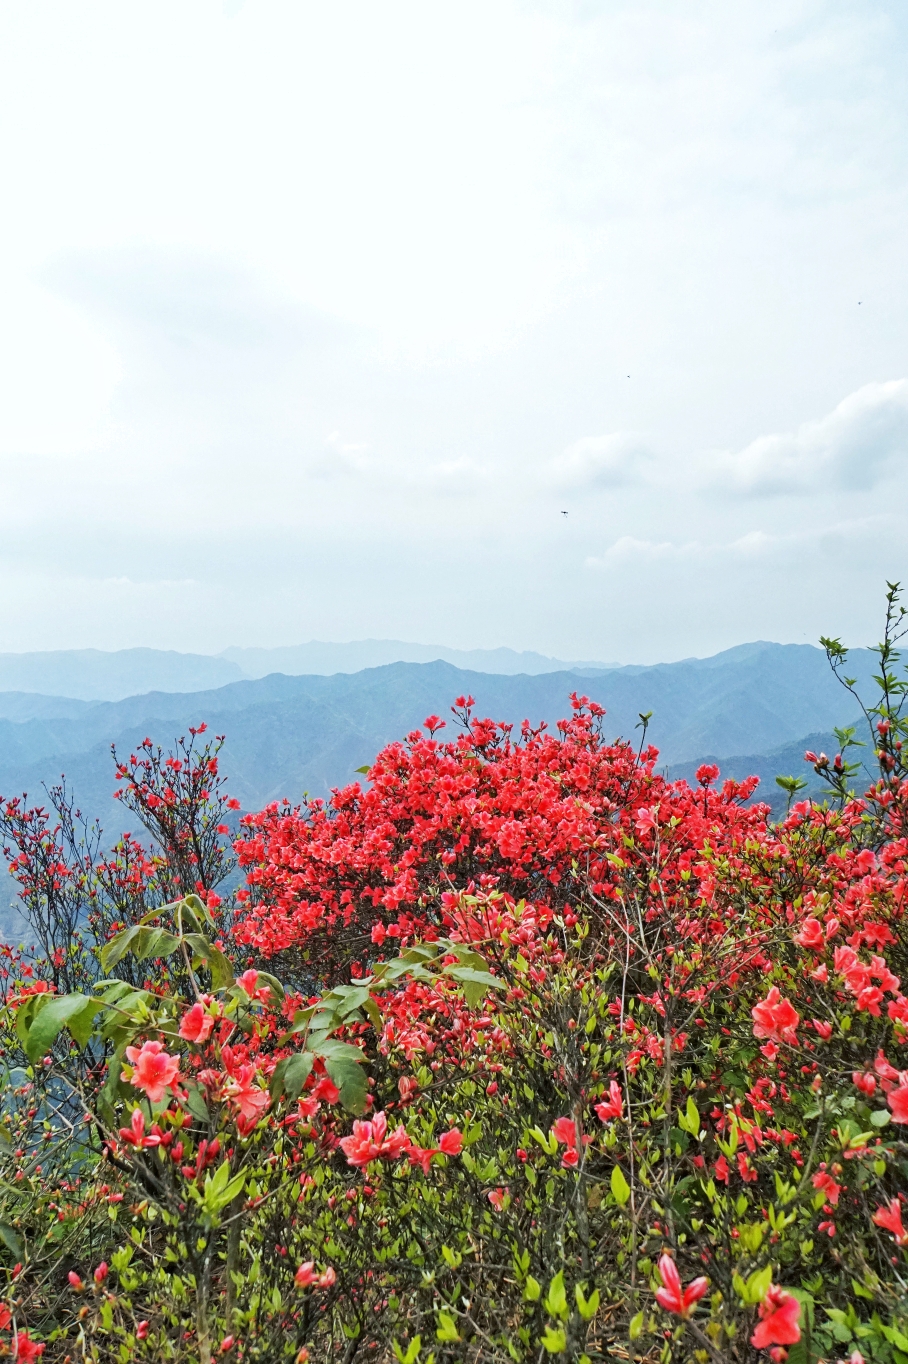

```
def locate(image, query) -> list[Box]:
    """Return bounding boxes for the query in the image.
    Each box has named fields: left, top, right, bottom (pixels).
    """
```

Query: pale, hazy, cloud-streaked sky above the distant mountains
left=0, top=0, right=908, bottom=663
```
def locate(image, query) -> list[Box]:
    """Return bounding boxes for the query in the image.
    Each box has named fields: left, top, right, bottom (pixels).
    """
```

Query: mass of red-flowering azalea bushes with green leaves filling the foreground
left=0, top=588, right=908, bottom=1364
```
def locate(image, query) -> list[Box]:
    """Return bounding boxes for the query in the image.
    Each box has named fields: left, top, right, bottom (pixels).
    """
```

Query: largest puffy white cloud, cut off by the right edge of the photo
left=708, top=379, right=908, bottom=496
